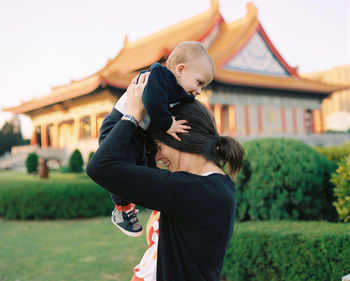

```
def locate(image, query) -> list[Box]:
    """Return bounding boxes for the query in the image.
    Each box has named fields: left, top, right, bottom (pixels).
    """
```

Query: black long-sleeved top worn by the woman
left=86, top=120, right=236, bottom=281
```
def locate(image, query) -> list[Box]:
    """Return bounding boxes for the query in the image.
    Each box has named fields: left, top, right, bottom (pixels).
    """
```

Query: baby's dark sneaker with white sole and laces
left=111, top=207, right=143, bottom=237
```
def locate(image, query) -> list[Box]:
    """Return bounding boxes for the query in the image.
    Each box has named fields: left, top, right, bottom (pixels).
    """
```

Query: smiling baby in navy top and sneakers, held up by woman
left=99, top=41, right=215, bottom=237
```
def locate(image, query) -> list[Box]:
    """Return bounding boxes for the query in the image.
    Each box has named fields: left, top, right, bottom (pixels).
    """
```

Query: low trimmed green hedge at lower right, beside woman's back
left=222, top=221, right=350, bottom=281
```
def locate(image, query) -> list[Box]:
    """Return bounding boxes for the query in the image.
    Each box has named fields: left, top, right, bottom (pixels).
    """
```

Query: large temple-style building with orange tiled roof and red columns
left=5, top=0, right=341, bottom=160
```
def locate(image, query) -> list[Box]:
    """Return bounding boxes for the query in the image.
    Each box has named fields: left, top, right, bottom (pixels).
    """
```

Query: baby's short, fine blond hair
left=166, top=41, right=215, bottom=73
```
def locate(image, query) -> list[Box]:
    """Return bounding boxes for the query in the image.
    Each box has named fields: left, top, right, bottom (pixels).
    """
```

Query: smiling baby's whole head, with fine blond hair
left=166, top=41, right=215, bottom=96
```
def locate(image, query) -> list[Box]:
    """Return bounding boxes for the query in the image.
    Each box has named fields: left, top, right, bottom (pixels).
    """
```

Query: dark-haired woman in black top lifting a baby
left=86, top=74, right=244, bottom=281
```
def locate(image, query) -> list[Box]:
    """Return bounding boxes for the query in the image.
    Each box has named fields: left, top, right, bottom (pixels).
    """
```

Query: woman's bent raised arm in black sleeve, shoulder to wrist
left=86, top=120, right=175, bottom=212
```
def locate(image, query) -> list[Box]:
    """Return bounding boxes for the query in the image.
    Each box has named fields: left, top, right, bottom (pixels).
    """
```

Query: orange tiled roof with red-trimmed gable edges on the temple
left=4, top=0, right=339, bottom=113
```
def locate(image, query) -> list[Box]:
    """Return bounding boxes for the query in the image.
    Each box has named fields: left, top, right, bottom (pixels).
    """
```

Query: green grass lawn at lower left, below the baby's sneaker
left=0, top=211, right=150, bottom=281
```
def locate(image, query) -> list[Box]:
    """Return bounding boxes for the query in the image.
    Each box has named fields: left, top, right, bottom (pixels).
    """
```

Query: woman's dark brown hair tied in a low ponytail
left=151, top=100, right=244, bottom=175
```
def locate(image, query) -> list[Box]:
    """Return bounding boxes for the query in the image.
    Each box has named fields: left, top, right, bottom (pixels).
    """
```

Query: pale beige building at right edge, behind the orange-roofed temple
left=303, top=65, right=350, bottom=131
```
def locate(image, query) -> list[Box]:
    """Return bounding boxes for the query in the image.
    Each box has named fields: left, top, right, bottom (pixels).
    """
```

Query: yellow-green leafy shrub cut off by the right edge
left=331, top=158, right=350, bottom=222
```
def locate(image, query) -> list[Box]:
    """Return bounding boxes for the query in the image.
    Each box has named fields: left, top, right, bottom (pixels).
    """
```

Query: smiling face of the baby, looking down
left=177, top=56, right=214, bottom=97
